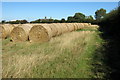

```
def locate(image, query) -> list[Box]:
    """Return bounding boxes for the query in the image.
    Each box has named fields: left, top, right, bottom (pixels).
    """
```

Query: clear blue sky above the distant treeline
left=2, top=2, right=118, bottom=21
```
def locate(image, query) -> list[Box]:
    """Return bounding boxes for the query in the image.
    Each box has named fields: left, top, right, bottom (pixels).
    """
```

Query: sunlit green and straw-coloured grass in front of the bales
left=2, top=30, right=103, bottom=78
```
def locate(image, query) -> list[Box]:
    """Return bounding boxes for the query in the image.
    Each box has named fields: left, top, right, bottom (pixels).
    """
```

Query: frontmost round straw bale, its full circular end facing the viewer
left=29, top=24, right=52, bottom=42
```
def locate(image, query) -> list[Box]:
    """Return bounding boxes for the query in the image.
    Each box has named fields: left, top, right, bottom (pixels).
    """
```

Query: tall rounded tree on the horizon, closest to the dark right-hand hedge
left=95, top=8, right=106, bottom=21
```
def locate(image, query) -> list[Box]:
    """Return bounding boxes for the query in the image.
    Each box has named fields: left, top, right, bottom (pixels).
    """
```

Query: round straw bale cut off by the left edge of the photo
left=1, top=24, right=14, bottom=39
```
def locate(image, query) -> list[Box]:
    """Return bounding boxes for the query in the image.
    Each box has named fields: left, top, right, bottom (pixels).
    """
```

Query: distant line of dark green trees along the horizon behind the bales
left=1, top=8, right=106, bottom=24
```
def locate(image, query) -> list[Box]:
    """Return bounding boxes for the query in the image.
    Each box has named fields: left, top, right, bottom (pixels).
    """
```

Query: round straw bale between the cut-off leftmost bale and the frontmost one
left=10, top=24, right=33, bottom=42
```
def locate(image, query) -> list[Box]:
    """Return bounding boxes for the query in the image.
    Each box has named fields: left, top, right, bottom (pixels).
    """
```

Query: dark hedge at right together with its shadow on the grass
left=93, top=7, right=120, bottom=80
